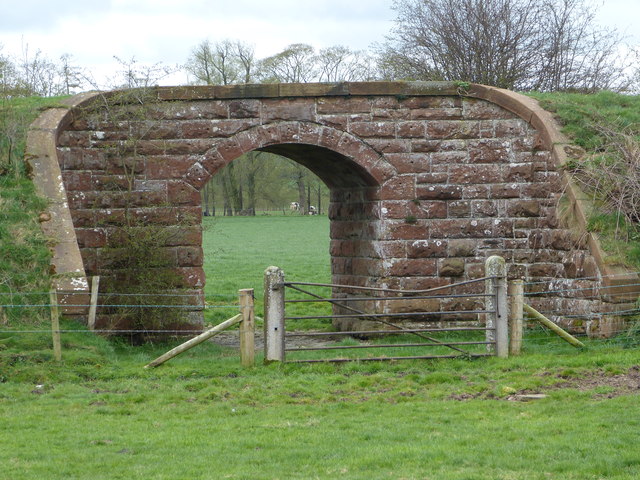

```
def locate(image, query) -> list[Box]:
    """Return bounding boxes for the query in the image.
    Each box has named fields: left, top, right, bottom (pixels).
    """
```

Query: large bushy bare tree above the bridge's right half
left=378, top=0, right=625, bottom=91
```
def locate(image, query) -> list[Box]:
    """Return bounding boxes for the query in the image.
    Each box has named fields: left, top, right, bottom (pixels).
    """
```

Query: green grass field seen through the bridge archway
left=203, top=215, right=331, bottom=328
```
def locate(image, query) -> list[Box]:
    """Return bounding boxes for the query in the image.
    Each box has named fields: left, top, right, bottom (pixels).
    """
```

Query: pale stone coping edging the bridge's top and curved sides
left=25, top=81, right=639, bottom=304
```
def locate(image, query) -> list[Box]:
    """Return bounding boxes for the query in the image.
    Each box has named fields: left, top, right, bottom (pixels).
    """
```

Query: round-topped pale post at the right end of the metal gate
left=485, top=255, right=509, bottom=358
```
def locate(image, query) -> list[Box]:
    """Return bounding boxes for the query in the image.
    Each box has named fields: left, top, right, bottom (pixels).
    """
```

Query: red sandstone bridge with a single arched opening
left=28, top=82, right=636, bottom=334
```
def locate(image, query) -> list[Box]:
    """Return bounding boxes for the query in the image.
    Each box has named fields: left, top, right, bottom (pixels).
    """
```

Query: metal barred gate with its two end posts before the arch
left=265, top=257, right=507, bottom=363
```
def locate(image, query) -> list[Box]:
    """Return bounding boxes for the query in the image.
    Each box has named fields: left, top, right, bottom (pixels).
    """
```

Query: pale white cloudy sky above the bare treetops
left=0, top=0, right=640, bottom=88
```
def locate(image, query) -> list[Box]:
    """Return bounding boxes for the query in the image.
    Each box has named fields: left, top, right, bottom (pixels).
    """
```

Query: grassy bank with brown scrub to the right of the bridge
left=531, top=92, right=640, bottom=271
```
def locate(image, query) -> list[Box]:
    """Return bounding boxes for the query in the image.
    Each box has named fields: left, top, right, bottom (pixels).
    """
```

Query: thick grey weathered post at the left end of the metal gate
left=264, top=267, right=284, bottom=363
